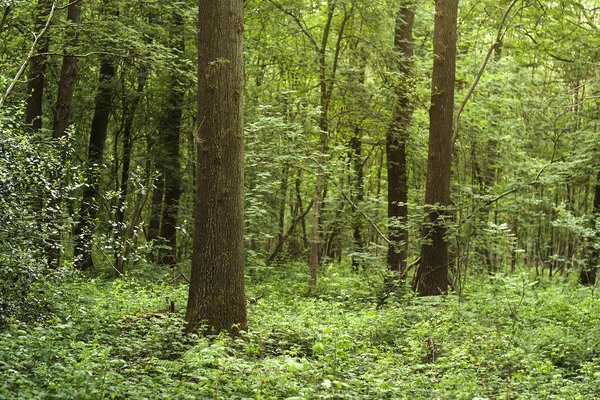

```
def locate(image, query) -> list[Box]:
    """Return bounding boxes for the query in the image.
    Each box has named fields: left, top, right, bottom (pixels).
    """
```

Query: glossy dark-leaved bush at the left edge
left=0, top=109, right=75, bottom=328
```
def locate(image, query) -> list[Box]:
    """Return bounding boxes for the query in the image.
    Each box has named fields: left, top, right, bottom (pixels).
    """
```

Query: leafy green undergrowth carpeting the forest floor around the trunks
left=0, top=264, right=600, bottom=400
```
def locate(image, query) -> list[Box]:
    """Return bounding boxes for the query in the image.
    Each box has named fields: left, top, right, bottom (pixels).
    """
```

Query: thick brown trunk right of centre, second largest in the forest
left=417, top=0, right=458, bottom=296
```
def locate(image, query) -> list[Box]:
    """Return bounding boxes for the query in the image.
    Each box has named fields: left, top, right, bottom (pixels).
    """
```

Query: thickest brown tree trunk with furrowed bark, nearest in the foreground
left=186, top=0, right=248, bottom=334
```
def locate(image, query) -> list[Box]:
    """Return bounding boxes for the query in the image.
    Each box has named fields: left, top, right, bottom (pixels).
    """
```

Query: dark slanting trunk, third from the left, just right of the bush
left=74, top=57, right=115, bottom=270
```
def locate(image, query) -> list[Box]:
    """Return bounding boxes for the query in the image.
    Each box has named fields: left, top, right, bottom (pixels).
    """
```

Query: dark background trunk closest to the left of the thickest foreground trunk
left=159, top=12, right=185, bottom=266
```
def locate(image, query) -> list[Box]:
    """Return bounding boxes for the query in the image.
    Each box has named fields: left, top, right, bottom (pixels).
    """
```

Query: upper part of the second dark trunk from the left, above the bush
left=52, top=2, right=81, bottom=138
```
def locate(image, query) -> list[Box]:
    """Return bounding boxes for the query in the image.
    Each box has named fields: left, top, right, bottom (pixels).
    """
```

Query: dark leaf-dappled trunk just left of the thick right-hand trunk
left=386, top=2, right=415, bottom=275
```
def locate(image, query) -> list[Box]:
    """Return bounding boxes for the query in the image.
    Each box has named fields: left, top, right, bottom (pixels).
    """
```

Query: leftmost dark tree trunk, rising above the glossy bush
left=25, top=0, right=52, bottom=131
